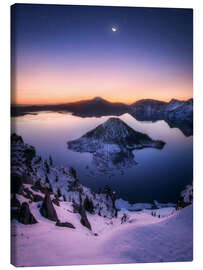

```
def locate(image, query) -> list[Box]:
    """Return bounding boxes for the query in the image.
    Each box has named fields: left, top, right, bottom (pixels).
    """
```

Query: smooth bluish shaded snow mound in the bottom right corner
left=100, top=206, right=193, bottom=263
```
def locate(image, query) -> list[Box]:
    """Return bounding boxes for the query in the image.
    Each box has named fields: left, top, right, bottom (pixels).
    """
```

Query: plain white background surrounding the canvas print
left=0, top=0, right=203, bottom=270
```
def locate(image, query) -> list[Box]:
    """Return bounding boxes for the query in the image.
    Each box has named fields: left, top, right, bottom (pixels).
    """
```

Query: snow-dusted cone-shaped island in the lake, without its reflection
left=68, top=117, right=164, bottom=152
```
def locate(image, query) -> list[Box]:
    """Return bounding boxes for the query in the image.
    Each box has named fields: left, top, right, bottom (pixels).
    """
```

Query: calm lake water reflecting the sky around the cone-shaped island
left=12, top=112, right=193, bottom=202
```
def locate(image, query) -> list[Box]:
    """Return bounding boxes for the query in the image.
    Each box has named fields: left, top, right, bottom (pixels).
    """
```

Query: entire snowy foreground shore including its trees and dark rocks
left=11, top=134, right=193, bottom=266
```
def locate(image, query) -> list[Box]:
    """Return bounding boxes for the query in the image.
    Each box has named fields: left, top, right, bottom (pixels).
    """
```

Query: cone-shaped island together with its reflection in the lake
left=67, top=117, right=165, bottom=173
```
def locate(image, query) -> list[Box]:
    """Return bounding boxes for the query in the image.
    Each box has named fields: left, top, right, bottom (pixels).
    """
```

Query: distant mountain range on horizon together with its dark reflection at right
left=11, top=97, right=193, bottom=136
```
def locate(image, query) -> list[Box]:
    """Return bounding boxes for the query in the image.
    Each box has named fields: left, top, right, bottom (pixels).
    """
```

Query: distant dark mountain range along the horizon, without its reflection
left=11, top=97, right=193, bottom=117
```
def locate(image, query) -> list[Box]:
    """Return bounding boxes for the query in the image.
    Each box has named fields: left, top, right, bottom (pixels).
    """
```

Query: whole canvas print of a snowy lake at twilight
left=11, top=4, right=193, bottom=266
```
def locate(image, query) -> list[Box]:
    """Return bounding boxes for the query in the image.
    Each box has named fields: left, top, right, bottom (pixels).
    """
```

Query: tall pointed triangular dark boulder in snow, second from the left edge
left=40, top=192, right=58, bottom=221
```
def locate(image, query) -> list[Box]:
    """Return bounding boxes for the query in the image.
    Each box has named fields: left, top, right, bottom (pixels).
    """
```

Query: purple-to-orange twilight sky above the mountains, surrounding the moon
left=11, top=4, right=193, bottom=104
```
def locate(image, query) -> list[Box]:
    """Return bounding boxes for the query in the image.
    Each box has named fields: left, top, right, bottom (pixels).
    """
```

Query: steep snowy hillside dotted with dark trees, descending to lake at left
left=11, top=134, right=116, bottom=217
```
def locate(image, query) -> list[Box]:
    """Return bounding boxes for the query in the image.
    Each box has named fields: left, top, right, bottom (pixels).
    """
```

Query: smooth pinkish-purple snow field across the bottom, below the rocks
left=12, top=205, right=193, bottom=266
